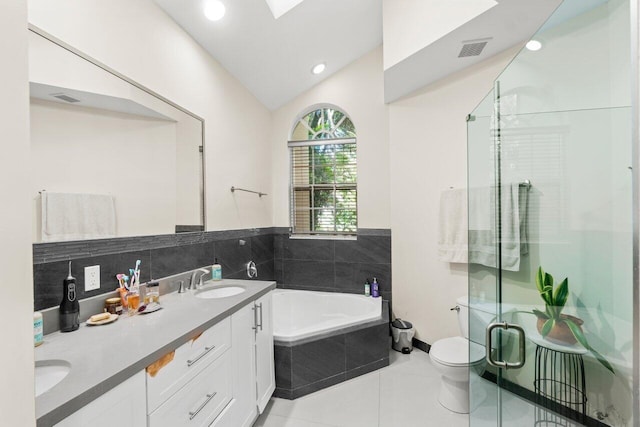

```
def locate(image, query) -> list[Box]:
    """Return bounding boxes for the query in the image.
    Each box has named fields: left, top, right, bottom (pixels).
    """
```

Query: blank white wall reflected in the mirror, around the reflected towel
left=31, top=99, right=178, bottom=242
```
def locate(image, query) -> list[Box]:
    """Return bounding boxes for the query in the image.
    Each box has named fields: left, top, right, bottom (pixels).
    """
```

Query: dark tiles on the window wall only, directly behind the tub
left=274, top=228, right=392, bottom=302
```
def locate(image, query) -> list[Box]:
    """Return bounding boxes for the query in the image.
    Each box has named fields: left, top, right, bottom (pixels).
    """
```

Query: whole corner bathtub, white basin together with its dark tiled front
left=272, top=289, right=391, bottom=399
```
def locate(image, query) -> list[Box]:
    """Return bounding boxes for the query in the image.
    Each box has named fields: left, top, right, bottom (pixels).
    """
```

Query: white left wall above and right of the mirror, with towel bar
left=29, top=0, right=273, bottom=230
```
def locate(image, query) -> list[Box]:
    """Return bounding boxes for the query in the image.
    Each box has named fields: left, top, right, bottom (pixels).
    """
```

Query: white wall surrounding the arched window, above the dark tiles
left=270, top=47, right=391, bottom=228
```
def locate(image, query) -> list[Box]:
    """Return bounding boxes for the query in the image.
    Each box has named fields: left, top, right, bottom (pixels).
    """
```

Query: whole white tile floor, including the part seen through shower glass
left=254, top=349, right=581, bottom=427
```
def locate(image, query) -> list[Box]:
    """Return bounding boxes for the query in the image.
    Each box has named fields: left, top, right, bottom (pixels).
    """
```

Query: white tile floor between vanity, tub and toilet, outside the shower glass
left=254, top=349, right=468, bottom=427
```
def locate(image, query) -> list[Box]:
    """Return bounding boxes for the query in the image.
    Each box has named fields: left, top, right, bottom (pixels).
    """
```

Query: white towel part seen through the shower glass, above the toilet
left=469, top=183, right=527, bottom=271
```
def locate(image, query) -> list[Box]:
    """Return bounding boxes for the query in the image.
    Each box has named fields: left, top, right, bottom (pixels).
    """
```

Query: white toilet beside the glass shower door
left=429, top=296, right=496, bottom=414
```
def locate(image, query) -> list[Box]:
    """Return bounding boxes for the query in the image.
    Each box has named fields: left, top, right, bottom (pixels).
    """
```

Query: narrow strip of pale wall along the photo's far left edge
left=0, top=0, right=35, bottom=427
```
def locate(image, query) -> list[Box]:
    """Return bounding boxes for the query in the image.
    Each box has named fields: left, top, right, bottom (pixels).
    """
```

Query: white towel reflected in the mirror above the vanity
left=42, top=191, right=116, bottom=242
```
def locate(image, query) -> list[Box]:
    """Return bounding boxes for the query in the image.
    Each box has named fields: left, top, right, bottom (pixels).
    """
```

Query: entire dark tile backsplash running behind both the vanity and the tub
left=33, top=228, right=391, bottom=310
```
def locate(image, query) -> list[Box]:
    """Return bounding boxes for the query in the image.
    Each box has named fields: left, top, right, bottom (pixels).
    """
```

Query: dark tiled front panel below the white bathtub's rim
left=274, top=304, right=391, bottom=399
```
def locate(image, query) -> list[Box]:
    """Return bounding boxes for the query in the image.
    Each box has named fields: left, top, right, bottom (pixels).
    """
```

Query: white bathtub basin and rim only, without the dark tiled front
left=273, top=289, right=382, bottom=342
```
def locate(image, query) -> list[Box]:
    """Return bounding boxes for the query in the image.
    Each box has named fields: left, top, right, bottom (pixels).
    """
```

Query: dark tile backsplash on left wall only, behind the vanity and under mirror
left=33, top=228, right=274, bottom=310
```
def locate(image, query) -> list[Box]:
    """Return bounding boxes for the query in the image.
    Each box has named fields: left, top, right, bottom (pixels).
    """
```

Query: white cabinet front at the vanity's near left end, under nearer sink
left=55, top=372, right=147, bottom=427
